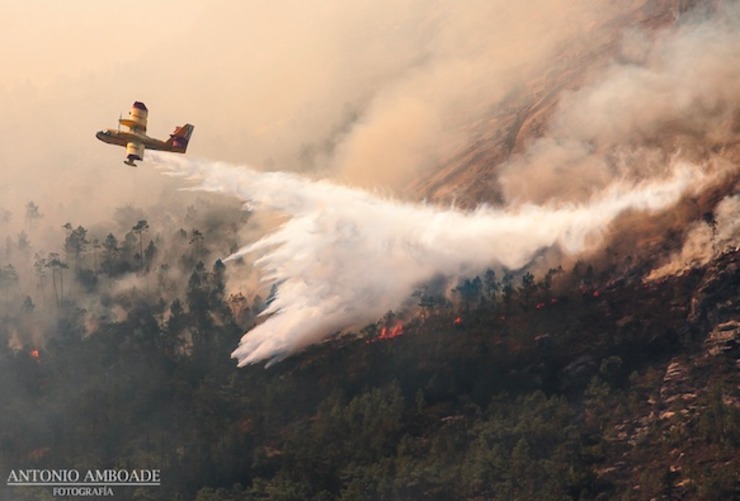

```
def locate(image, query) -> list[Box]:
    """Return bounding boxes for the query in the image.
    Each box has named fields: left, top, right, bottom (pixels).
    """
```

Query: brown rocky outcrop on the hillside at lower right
left=596, top=251, right=740, bottom=499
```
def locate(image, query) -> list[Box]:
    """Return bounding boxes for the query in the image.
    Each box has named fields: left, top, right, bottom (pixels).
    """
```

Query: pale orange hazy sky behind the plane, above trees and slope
left=0, top=0, right=614, bottom=230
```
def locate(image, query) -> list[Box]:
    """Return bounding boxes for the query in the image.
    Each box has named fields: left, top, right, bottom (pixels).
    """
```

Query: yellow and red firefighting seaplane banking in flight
left=95, top=101, right=194, bottom=167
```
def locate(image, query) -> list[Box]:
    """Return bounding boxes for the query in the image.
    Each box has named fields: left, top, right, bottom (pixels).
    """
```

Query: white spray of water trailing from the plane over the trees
left=152, top=151, right=704, bottom=366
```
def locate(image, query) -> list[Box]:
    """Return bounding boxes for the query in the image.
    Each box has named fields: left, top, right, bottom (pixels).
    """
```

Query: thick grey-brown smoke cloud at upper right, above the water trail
left=499, top=6, right=740, bottom=203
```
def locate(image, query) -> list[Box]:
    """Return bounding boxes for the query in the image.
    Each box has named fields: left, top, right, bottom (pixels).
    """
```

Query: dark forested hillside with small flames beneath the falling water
left=0, top=198, right=740, bottom=501
